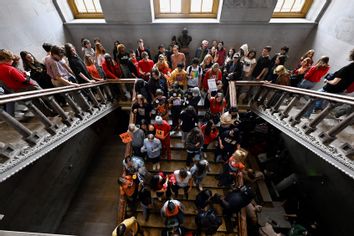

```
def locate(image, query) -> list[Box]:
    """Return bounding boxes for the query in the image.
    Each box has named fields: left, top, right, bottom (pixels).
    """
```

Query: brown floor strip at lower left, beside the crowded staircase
left=57, top=136, right=124, bottom=236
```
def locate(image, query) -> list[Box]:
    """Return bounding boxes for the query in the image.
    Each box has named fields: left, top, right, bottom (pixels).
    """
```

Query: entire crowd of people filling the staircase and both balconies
left=0, top=36, right=354, bottom=235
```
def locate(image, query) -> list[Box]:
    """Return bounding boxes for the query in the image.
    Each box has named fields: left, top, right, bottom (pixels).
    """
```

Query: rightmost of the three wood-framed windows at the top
left=273, top=0, right=313, bottom=18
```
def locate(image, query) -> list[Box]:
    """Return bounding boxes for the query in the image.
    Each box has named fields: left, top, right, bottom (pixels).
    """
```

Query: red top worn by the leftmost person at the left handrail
left=0, top=63, right=33, bottom=92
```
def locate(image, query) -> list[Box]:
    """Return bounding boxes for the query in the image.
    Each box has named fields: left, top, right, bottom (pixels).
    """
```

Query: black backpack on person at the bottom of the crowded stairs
left=195, top=208, right=222, bottom=234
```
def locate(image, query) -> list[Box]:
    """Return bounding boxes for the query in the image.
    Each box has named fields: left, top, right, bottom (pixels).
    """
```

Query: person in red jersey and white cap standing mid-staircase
left=154, top=116, right=171, bottom=160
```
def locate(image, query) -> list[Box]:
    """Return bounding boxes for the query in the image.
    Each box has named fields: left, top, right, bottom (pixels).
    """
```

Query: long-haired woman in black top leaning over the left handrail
left=64, top=43, right=94, bottom=84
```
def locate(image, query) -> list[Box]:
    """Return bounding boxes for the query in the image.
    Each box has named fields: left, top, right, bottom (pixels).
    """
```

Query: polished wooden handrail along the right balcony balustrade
left=231, top=81, right=354, bottom=105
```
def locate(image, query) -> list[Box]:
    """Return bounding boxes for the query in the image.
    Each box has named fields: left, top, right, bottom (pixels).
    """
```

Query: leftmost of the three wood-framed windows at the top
left=67, top=0, right=103, bottom=19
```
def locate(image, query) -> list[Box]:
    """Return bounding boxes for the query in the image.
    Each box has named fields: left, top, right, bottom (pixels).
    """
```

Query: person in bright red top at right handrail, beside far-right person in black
left=298, top=56, right=330, bottom=89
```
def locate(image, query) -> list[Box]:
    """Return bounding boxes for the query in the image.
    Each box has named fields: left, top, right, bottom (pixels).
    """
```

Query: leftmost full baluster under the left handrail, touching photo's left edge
left=0, top=109, right=40, bottom=146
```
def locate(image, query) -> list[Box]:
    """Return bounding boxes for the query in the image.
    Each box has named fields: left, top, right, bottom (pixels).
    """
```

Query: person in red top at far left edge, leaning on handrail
left=0, top=49, right=40, bottom=92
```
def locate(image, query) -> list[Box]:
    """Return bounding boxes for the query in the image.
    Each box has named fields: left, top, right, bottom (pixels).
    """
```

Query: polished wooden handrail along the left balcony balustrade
left=0, top=79, right=137, bottom=104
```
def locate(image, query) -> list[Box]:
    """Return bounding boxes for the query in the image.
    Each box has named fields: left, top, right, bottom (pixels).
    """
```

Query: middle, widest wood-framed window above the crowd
left=154, top=0, right=219, bottom=19
